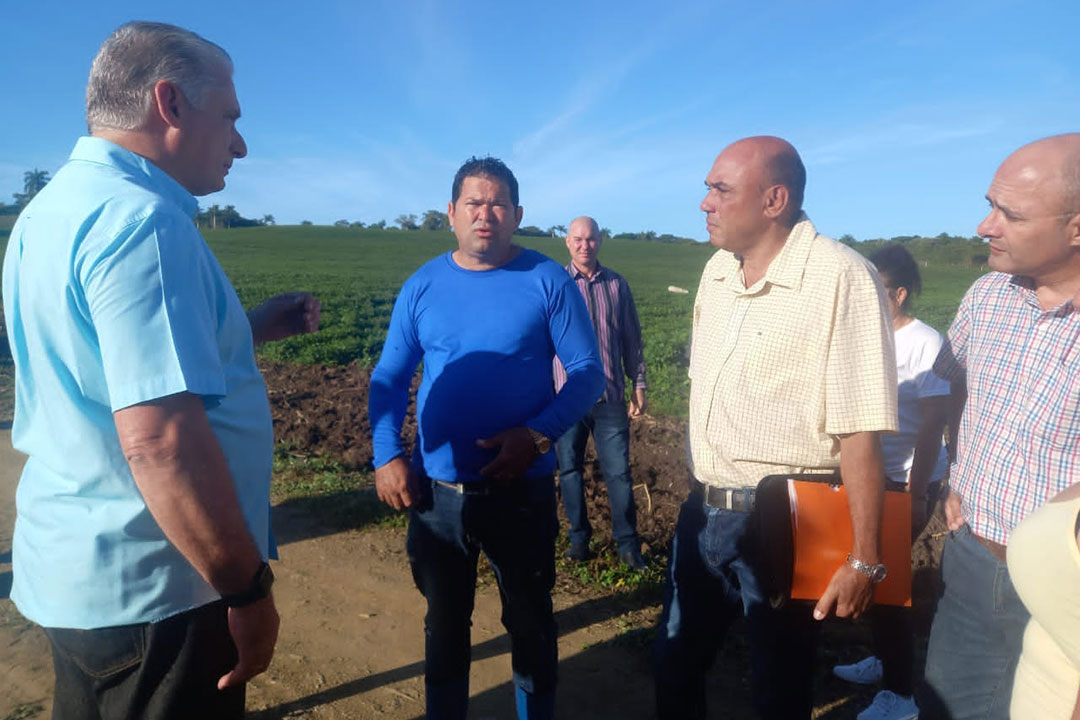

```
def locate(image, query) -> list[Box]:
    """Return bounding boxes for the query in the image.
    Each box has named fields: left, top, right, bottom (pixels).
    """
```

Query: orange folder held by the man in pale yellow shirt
left=787, top=478, right=912, bottom=607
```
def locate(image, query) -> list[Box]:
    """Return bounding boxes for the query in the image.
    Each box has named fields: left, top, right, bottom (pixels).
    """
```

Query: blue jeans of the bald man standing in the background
left=555, top=402, right=640, bottom=552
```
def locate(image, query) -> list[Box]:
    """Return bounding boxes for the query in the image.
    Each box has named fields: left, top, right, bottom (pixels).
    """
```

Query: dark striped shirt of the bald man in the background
left=553, top=262, right=647, bottom=403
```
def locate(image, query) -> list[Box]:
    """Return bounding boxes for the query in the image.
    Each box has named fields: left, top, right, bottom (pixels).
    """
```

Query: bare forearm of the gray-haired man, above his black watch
left=113, top=393, right=262, bottom=595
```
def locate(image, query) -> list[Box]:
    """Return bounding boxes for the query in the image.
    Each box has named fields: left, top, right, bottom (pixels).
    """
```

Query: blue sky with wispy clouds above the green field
left=0, top=0, right=1080, bottom=240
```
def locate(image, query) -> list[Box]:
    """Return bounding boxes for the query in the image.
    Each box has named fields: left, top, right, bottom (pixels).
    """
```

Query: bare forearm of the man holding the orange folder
left=840, top=433, right=885, bottom=563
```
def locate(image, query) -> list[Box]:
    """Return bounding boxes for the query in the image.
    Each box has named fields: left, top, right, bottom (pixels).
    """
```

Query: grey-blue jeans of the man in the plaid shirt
left=919, top=526, right=1030, bottom=720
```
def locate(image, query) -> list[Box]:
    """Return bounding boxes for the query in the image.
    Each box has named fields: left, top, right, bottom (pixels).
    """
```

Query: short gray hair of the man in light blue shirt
left=86, top=22, right=232, bottom=132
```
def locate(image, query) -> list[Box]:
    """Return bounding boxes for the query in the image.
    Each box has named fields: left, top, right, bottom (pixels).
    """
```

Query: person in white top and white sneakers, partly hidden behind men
left=833, top=244, right=949, bottom=720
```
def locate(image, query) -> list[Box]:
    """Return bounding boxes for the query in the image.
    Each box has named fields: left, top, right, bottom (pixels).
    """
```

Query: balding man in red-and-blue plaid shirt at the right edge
left=919, top=133, right=1080, bottom=720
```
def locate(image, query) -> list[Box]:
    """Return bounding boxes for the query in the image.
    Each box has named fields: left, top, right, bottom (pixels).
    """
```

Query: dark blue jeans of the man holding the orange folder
left=652, top=492, right=820, bottom=720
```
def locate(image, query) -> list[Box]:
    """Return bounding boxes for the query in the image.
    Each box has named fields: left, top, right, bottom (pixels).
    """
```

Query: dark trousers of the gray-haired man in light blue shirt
left=45, top=601, right=244, bottom=720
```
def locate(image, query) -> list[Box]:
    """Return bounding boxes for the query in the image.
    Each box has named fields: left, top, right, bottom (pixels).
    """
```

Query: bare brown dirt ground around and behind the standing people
left=0, top=363, right=944, bottom=720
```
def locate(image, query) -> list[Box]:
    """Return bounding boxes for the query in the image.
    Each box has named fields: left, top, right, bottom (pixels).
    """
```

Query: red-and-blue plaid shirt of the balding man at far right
left=934, top=272, right=1080, bottom=543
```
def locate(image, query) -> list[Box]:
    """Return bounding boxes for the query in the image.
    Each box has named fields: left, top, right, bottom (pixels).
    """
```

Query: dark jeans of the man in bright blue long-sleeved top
left=406, top=475, right=558, bottom=720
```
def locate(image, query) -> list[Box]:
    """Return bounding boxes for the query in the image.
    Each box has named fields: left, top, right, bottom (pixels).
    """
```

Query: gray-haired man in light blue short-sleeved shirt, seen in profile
left=3, top=23, right=320, bottom=719
